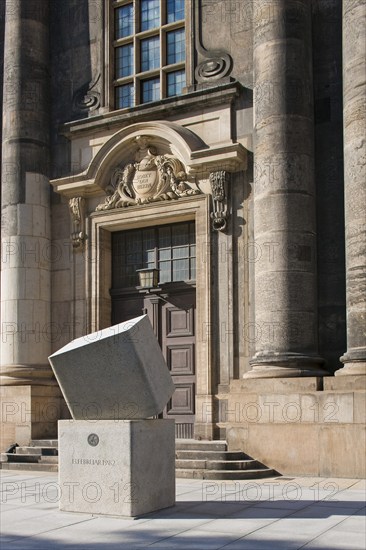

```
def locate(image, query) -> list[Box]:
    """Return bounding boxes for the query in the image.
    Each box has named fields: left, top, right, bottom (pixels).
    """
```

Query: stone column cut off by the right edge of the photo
left=336, top=0, right=366, bottom=375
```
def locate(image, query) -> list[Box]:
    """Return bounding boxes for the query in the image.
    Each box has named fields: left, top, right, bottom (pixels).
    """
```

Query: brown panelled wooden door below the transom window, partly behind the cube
left=111, top=224, right=196, bottom=438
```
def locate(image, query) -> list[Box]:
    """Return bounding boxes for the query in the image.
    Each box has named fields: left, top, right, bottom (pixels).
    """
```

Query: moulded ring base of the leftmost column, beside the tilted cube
left=0, top=364, right=58, bottom=386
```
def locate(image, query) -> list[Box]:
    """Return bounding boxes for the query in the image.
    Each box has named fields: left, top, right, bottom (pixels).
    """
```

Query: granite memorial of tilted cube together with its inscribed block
left=49, top=315, right=175, bottom=517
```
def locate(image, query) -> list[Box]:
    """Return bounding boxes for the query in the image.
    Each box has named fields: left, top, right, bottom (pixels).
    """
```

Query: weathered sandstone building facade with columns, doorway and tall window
left=0, top=0, right=366, bottom=477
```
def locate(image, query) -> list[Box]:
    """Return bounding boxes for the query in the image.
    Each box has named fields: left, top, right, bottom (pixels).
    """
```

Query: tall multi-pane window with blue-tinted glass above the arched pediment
left=112, top=0, right=186, bottom=109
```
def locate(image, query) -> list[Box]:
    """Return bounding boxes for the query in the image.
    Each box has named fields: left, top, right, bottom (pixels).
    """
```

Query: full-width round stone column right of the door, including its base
left=244, top=0, right=325, bottom=378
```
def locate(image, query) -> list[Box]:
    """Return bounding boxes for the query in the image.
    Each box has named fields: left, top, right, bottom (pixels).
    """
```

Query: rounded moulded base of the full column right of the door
left=243, top=352, right=329, bottom=378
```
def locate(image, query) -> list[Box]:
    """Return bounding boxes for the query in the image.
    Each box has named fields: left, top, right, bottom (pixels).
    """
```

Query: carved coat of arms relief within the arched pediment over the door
left=96, top=136, right=200, bottom=210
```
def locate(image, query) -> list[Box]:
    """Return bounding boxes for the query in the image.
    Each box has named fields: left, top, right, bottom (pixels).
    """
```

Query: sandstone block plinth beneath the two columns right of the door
left=226, top=376, right=366, bottom=479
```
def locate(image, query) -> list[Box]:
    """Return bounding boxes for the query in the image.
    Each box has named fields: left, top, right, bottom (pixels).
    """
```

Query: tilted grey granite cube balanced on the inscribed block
left=49, top=315, right=174, bottom=420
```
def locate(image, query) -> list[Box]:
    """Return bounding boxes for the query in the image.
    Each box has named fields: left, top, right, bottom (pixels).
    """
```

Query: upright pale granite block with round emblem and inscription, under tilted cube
left=59, top=419, right=175, bottom=517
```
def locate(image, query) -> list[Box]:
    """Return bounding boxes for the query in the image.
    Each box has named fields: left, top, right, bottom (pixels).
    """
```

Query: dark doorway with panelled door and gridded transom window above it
left=110, top=221, right=196, bottom=438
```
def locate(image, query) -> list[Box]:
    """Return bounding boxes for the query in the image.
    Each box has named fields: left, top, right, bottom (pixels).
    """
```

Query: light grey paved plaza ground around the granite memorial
left=0, top=470, right=366, bottom=550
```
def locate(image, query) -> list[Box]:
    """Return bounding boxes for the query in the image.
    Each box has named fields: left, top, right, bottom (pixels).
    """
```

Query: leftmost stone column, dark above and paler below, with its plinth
left=0, top=0, right=57, bottom=444
